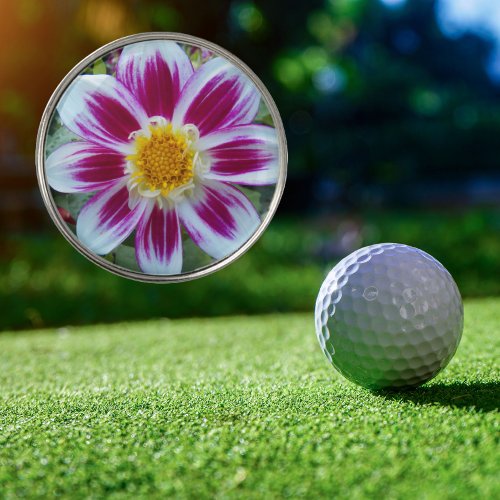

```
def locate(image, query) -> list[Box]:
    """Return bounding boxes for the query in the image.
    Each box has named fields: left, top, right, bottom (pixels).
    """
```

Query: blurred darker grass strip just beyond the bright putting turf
left=0, top=209, right=500, bottom=330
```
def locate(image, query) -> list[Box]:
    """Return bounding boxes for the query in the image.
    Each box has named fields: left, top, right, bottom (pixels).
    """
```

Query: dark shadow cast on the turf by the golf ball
left=379, top=382, right=500, bottom=412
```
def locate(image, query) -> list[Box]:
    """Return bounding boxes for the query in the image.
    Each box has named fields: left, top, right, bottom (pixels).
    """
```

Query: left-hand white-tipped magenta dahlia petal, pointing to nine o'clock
left=46, top=141, right=125, bottom=193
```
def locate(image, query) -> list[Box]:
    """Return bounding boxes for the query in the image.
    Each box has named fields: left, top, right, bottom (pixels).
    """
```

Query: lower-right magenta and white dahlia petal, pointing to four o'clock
left=177, top=180, right=260, bottom=259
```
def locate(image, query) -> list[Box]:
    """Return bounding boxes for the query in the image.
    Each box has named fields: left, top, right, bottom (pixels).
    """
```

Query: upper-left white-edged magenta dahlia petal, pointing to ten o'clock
left=57, top=75, right=148, bottom=154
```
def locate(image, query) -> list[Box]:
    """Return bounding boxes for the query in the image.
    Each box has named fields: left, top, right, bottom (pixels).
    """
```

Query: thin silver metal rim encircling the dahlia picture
left=35, top=32, right=288, bottom=283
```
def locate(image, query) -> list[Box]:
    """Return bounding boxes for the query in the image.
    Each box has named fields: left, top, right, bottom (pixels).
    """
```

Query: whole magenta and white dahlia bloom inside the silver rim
left=46, top=41, right=279, bottom=274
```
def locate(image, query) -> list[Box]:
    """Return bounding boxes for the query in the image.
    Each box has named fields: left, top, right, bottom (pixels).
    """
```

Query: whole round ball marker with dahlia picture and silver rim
left=36, top=33, right=287, bottom=282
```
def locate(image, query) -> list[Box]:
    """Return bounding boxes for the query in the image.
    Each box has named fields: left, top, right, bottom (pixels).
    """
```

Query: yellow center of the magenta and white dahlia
left=127, top=123, right=195, bottom=196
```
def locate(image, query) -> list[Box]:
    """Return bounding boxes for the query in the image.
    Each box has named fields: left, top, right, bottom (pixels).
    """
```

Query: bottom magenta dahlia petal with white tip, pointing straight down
left=135, top=204, right=182, bottom=274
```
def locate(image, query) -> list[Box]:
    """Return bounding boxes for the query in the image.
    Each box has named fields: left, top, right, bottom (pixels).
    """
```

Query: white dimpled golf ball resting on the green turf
left=315, top=243, right=463, bottom=389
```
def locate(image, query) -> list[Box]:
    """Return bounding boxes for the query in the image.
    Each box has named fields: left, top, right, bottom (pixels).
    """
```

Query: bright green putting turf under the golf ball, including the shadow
left=0, top=299, right=500, bottom=499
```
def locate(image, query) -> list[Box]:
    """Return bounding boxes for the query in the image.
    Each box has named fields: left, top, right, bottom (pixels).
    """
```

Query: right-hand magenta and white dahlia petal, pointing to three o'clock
left=198, top=124, right=279, bottom=186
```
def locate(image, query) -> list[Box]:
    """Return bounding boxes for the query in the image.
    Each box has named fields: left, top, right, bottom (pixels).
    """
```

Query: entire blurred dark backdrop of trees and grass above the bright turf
left=0, top=0, right=500, bottom=330
